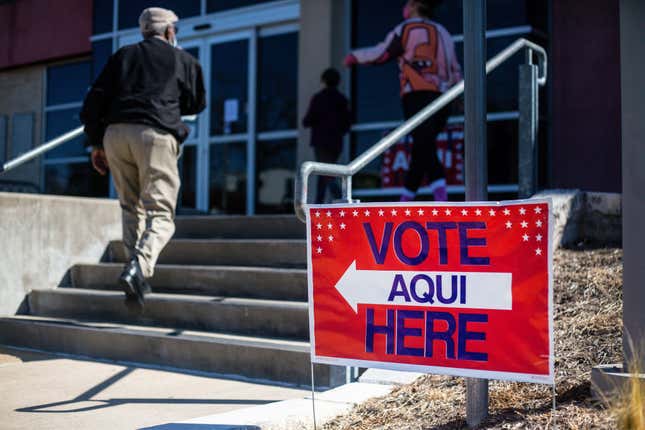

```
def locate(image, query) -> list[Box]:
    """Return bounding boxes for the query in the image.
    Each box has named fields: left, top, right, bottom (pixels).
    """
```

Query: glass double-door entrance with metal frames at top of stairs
left=119, top=8, right=298, bottom=215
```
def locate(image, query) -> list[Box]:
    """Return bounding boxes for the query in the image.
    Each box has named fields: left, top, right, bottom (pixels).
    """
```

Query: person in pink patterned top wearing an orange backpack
left=344, top=0, right=462, bottom=201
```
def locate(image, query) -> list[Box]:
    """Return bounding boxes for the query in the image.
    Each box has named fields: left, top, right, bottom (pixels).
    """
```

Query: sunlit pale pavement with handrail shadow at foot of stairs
left=0, top=348, right=307, bottom=430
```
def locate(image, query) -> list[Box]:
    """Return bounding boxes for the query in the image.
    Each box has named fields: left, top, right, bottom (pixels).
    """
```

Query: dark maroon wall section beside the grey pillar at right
left=549, top=0, right=621, bottom=192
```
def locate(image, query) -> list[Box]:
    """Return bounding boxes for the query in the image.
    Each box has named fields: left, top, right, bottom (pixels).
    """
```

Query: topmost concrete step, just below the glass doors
left=175, top=215, right=305, bottom=239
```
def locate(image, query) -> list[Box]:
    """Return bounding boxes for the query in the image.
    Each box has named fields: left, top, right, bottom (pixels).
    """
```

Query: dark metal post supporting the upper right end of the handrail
left=517, top=57, right=538, bottom=199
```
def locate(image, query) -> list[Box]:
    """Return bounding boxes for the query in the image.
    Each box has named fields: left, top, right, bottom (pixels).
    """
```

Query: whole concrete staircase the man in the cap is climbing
left=0, top=216, right=345, bottom=387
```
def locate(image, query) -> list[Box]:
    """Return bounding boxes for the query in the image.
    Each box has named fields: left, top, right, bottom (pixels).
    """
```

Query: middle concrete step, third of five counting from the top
left=70, top=263, right=307, bottom=301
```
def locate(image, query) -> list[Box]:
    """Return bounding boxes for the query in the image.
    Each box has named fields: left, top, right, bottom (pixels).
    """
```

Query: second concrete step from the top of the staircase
left=109, top=239, right=307, bottom=268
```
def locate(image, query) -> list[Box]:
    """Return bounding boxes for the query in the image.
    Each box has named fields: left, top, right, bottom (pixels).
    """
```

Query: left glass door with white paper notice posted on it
left=208, top=31, right=255, bottom=214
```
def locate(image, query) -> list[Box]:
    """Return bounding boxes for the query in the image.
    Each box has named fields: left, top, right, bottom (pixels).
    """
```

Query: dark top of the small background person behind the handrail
left=302, top=88, right=351, bottom=153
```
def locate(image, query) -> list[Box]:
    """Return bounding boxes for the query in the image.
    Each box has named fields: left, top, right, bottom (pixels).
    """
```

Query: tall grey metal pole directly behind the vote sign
left=463, top=0, right=488, bottom=427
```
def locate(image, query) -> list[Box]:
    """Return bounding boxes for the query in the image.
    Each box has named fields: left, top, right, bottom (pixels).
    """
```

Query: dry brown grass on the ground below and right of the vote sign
left=324, top=249, right=623, bottom=430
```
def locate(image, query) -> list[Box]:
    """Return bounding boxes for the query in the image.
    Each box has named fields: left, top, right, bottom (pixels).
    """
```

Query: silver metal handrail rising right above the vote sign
left=294, top=38, right=547, bottom=222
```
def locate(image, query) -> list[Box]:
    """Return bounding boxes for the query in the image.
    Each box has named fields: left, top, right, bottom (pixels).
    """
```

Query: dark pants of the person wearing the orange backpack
left=401, top=91, right=450, bottom=192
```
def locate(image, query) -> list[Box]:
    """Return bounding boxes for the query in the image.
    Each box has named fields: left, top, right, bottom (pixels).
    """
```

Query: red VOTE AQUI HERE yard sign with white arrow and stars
left=307, top=199, right=553, bottom=383
